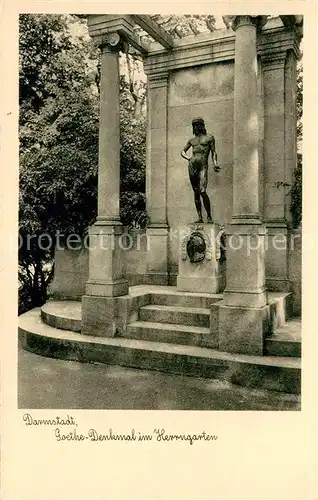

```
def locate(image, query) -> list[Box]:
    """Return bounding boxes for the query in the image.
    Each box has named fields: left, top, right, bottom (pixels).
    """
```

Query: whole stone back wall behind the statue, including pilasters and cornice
left=49, top=18, right=300, bottom=298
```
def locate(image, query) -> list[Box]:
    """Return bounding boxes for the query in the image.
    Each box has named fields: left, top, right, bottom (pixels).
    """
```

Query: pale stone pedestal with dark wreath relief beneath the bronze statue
left=177, top=224, right=221, bottom=293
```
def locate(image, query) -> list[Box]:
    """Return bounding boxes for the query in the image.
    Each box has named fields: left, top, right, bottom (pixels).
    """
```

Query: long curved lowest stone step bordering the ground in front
left=19, top=308, right=301, bottom=394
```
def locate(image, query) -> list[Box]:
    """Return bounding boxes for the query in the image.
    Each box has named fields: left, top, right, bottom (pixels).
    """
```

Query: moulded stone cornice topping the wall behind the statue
left=144, top=23, right=299, bottom=76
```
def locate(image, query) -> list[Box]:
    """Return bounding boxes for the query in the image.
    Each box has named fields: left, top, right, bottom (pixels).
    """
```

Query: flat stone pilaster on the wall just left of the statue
left=146, top=72, right=169, bottom=285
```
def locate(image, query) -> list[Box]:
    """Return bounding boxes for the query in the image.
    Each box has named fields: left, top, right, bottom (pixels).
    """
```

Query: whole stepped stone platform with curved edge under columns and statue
left=19, top=286, right=301, bottom=393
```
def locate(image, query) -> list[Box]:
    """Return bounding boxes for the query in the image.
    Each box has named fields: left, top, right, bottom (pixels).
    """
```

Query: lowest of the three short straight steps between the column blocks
left=124, top=321, right=211, bottom=347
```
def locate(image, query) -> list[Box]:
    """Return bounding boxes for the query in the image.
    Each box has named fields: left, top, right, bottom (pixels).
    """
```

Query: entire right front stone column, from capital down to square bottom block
left=219, top=16, right=267, bottom=354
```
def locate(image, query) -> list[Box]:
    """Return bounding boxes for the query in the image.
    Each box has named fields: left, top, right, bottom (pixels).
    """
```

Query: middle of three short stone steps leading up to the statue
left=139, top=304, right=210, bottom=328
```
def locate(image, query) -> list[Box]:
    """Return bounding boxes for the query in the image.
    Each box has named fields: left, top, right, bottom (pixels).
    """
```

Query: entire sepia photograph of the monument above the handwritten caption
left=17, top=9, right=306, bottom=412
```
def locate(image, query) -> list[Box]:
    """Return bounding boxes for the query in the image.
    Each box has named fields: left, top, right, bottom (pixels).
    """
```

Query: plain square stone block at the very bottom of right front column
left=218, top=305, right=270, bottom=356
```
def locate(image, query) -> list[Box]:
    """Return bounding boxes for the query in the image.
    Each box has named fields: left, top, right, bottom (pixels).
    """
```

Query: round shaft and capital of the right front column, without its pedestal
left=232, top=16, right=261, bottom=224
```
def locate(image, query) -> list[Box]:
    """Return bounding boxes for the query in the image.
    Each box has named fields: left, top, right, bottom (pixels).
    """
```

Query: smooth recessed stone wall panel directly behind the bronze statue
left=167, top=60, right=263, bottom=278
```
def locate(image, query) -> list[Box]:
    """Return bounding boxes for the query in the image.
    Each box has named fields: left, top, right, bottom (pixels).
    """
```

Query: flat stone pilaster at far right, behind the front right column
left=261, top=51, right=290, bottom=292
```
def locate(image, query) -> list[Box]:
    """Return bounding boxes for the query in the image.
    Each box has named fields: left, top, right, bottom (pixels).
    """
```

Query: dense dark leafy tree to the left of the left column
left=19, top=14, right=99, bottom=312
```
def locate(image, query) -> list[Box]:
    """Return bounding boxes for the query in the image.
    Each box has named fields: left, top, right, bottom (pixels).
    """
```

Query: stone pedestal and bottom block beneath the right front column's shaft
left=219, top=224, right=269, bottom=355
